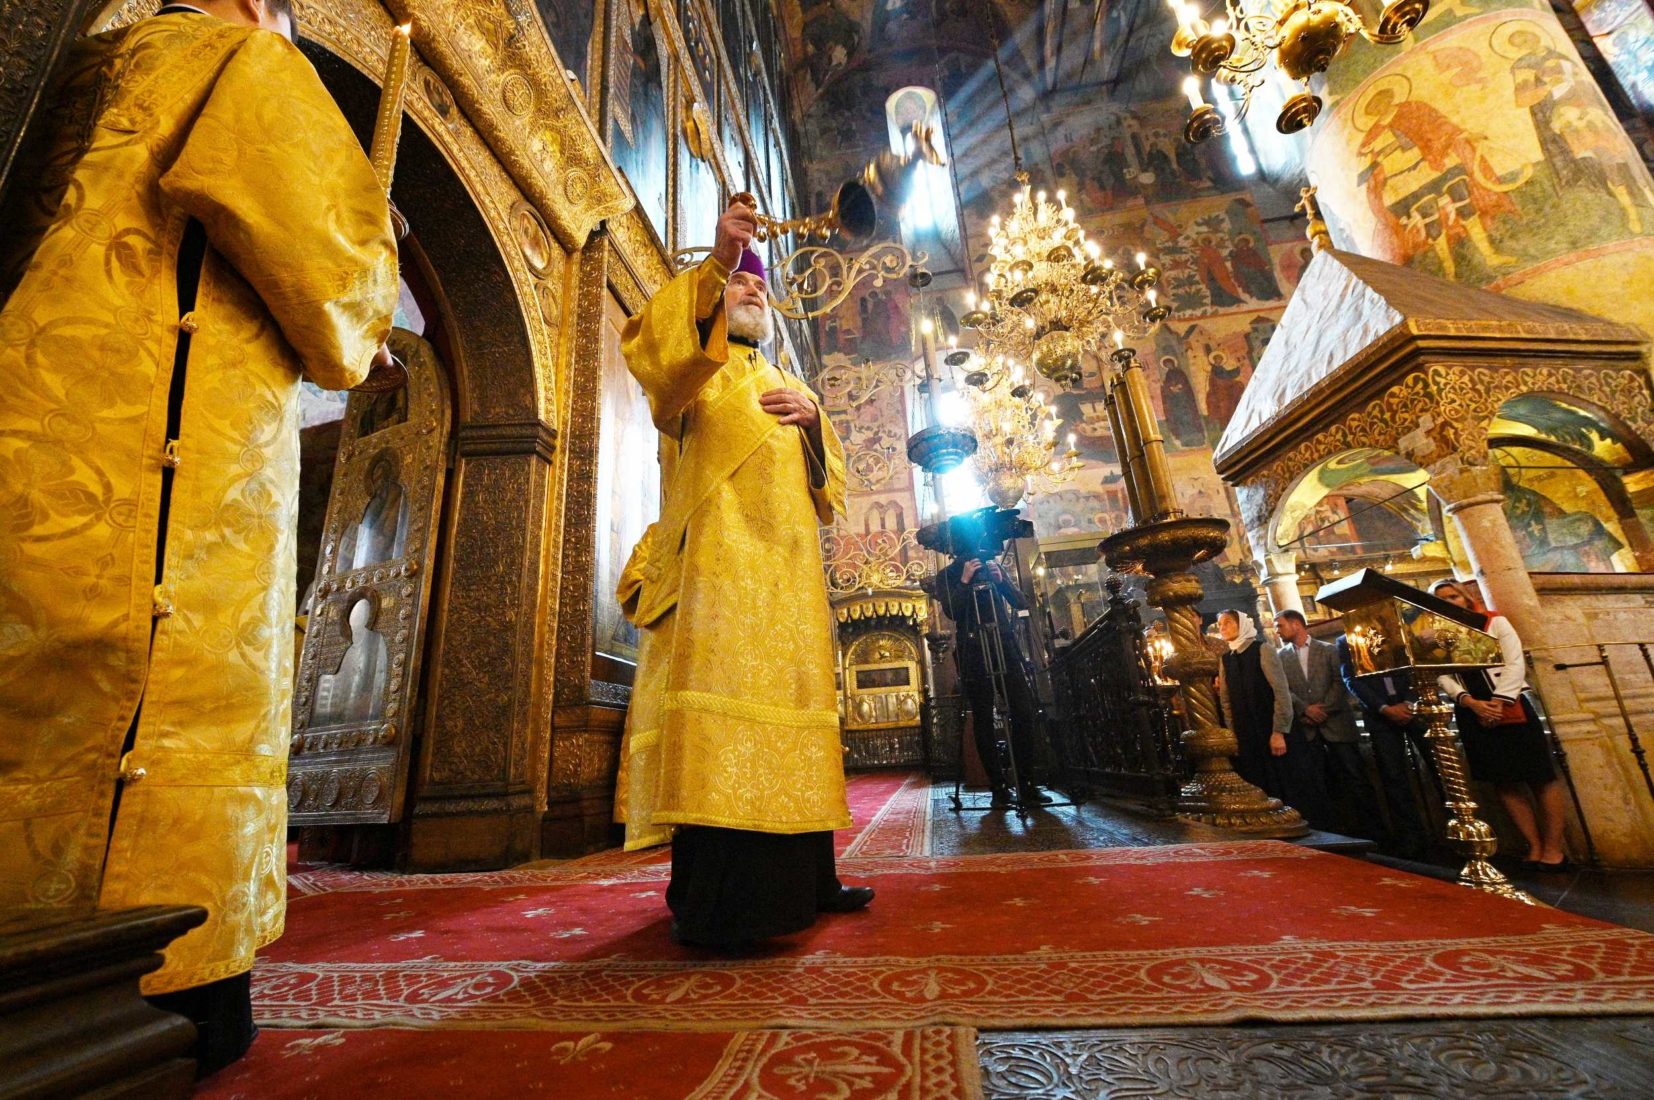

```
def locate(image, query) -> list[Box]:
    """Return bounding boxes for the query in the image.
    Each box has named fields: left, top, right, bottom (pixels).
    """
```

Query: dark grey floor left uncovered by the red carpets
left=931, top=787, right=1654, bottom=1100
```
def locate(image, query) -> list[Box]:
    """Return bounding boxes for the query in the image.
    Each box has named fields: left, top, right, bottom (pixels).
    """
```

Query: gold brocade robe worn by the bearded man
left=615, top=260, right=850, bottom=849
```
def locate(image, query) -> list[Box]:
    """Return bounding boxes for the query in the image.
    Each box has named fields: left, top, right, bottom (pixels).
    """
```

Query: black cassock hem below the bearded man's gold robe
left=667, top=825, right=840, bottom=945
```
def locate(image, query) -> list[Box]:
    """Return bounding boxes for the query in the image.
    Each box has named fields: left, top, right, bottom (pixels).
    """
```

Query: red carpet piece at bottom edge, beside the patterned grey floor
left=195, top=1027, right=982, bottom=1100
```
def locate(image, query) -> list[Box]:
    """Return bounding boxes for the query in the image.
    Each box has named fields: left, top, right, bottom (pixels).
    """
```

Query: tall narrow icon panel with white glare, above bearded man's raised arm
left=609, top=0, right=668, bottom=240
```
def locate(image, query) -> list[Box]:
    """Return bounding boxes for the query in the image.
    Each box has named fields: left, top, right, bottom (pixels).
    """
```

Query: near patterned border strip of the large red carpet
left=253, top=926, right=1654, bottom=1031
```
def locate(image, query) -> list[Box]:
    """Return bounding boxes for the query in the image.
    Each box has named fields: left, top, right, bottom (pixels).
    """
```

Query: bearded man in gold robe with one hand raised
left=617, top=203, right=873, bottom=946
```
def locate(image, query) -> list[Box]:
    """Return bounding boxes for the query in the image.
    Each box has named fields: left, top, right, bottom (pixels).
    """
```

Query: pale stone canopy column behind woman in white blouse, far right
left=1431, top=463, right=1654, bottom=867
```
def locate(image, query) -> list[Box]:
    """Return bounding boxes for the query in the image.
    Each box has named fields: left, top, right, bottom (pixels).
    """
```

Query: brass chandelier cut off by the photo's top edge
left=1166, top=0, right=1431, bottom=142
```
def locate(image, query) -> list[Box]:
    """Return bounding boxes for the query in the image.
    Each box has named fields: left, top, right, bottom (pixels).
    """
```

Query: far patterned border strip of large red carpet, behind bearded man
left=288, top=840, right=1317, bottom=900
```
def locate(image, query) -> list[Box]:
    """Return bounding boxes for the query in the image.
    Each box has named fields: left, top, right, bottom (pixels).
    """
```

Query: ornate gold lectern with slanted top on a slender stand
left=1315, top=569, right=1533, bottom=905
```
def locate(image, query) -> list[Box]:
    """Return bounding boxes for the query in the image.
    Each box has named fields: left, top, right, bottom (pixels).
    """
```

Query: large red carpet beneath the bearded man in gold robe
left=253, top=842, right=1654, bottom=1032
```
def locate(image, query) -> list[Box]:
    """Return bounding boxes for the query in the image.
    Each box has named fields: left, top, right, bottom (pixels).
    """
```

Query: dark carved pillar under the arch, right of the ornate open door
left=405, top=420, right=556, bottom=870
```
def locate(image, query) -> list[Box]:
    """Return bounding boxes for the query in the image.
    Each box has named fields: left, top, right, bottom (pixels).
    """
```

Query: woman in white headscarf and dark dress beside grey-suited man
left=1217, top=609, right=1330, bottom=829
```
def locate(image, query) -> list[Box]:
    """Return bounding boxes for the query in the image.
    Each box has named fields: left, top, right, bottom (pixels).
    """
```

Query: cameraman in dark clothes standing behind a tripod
left=938, top=556, right=1050, bottom=809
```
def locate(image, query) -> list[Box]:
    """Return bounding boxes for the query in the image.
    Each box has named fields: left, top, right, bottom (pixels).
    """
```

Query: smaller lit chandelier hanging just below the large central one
left=966, top=367, right=1085, bottom=508
